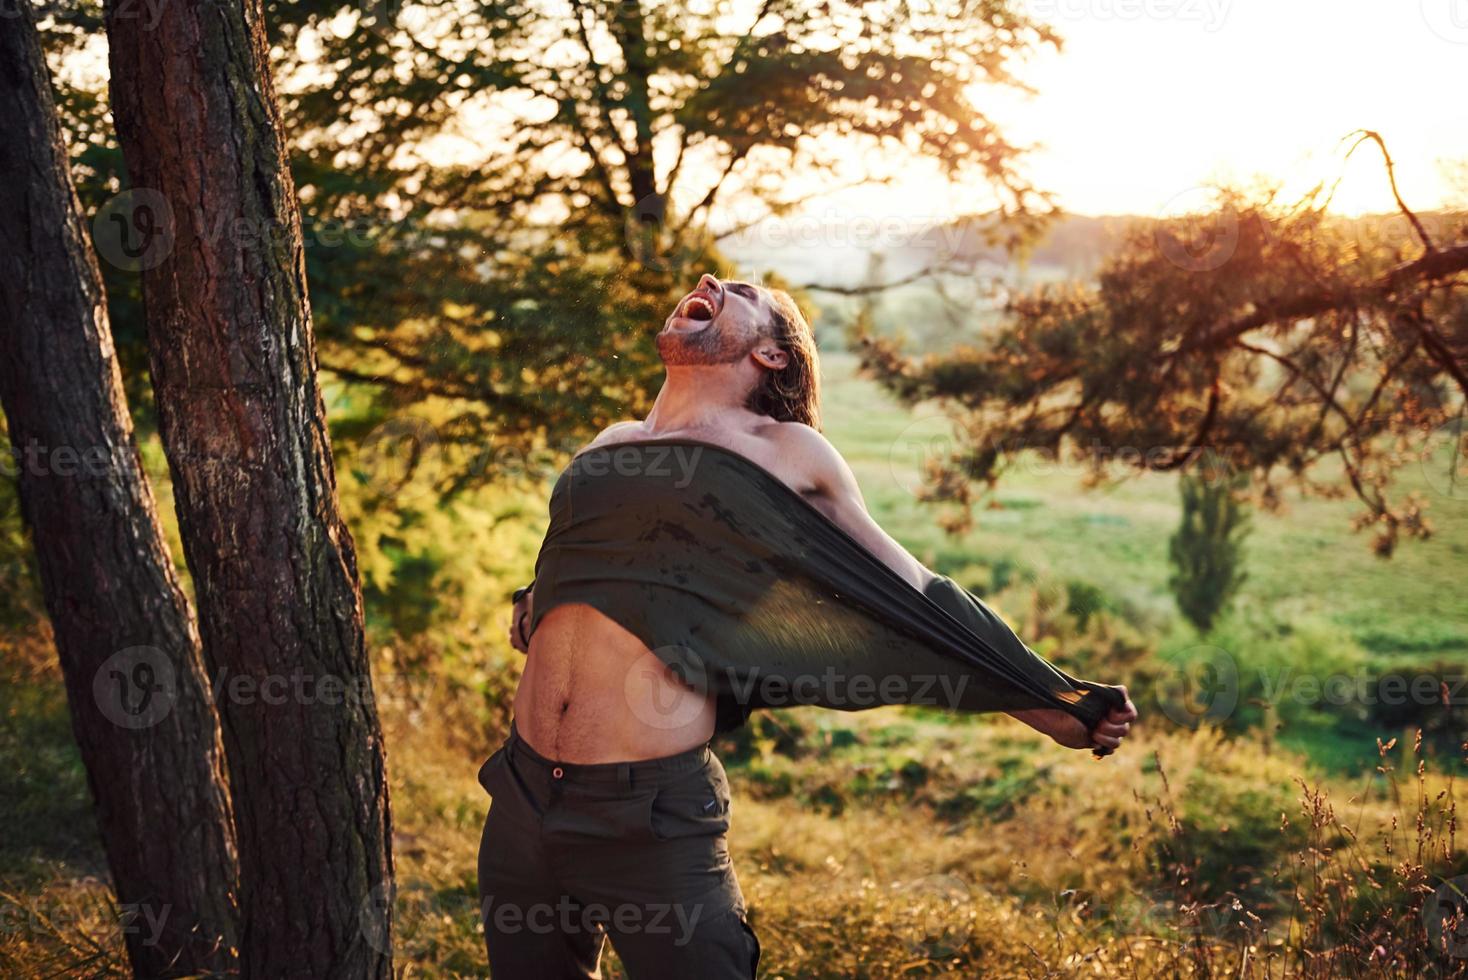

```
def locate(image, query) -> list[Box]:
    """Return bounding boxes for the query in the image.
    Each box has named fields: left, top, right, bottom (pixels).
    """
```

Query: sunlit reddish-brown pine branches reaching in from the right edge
left=856, top=178, right=1468, bottom=557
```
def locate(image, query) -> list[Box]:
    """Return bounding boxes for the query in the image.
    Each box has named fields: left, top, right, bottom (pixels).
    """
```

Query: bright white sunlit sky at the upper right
left=815, top=0, right=1468, bottom=214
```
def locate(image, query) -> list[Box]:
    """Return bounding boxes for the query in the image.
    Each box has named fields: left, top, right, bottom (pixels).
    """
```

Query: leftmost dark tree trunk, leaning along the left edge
left=0, top=3, right=238, bottom=977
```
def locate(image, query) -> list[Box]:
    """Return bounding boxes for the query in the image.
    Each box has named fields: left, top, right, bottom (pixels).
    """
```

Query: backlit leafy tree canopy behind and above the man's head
left=47, top=0, right=1058, bottom=498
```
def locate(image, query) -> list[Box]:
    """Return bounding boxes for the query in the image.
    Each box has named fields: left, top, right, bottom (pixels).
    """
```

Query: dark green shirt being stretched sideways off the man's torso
left=528, top=440, right=1124, bottom=732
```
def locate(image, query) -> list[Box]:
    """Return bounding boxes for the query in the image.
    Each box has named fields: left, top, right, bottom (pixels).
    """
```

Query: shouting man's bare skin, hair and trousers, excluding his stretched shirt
left=479, top=276, right=1136, bottom=980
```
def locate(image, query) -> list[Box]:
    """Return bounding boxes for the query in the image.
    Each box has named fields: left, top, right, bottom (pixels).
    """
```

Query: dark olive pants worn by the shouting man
left=479, top=725, right=759, bottom=980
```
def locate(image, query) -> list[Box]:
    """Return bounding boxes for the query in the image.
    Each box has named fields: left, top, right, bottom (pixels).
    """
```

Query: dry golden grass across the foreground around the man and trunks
left=0, top=636, right=1468, bottom=977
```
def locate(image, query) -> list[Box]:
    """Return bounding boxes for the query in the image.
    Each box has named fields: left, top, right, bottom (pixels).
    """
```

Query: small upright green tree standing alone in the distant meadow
left=1167, top=468, right=1249, bottom=632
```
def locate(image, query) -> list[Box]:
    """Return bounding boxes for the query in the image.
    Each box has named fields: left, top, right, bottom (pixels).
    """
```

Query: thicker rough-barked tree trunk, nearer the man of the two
left=106, top=0, right=392, bottom=980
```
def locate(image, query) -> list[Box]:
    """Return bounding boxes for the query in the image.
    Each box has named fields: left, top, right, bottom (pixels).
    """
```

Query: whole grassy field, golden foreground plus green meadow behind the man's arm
left=0, top=340, right=1468, bottom=977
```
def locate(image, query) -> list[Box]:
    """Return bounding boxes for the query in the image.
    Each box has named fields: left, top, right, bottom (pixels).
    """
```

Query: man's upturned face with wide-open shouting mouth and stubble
left=658, top=276, right=769, bottom=364
